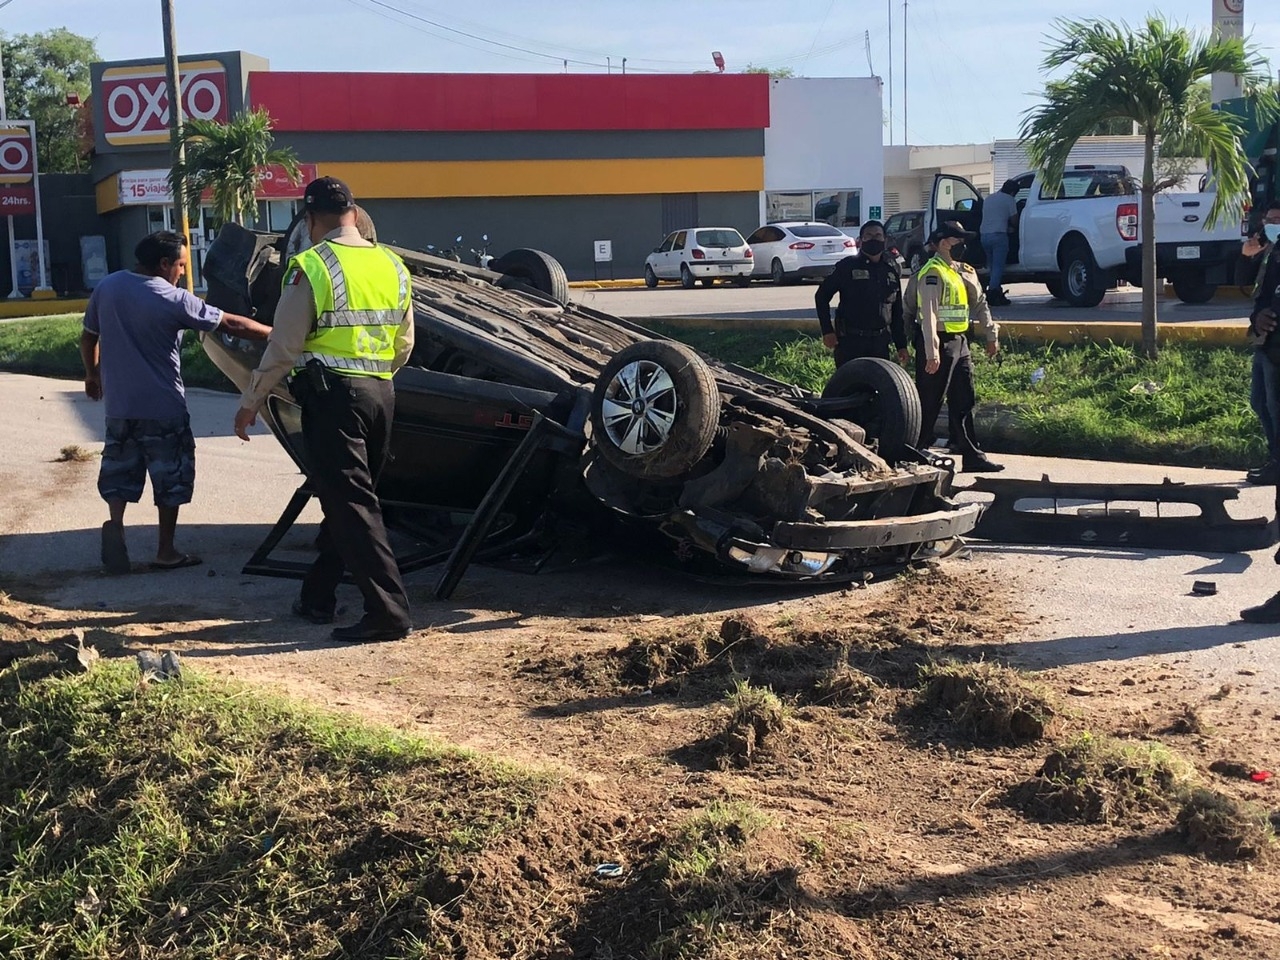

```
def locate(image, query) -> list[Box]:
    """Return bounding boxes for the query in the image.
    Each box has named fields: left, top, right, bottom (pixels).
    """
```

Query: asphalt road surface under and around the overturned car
left=0, top=371, right=1280, bottom=692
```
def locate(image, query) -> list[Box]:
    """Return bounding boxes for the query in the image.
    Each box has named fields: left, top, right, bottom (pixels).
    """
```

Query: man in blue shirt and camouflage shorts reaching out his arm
left=81, top=230, right=271, bottom=573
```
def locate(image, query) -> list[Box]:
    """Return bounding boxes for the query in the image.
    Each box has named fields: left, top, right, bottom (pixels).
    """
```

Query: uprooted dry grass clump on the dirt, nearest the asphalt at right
left=918, top=662, right=1057, bottom=744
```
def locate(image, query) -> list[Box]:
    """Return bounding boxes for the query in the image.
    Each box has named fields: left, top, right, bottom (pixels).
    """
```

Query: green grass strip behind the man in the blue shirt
left=0, top=314, right=233, bottom=392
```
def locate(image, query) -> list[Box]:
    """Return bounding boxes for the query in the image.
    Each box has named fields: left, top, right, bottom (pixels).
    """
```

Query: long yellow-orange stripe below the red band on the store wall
left=317, top=156, right=764, bottom=200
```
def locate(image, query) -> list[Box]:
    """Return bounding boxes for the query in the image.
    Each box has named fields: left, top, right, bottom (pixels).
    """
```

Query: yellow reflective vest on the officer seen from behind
left=285, top=241, right=410, bottom=379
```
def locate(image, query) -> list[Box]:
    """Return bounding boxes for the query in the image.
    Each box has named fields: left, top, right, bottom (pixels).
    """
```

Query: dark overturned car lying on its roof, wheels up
left=205, top=224, right=982, bottom=595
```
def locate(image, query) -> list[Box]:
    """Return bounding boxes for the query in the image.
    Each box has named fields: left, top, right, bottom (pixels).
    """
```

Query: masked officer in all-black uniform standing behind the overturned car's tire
left=813, top=220, right=908, bottom=367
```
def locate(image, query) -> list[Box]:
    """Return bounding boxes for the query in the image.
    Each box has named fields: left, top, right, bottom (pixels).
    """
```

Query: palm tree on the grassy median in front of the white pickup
left=1021, top=17, right=1275, bottom=357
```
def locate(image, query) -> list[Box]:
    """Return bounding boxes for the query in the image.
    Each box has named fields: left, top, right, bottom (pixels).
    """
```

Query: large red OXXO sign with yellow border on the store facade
left=101, top=60, right=228, bottom=147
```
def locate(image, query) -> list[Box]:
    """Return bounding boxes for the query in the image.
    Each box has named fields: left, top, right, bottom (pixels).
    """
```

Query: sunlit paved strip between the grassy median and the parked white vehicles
left=573, top=283, right=1248, bottom=329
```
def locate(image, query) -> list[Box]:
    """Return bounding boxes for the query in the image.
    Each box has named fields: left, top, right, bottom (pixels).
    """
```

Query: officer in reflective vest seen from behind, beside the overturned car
left=236, top=177, right=413, bottom=643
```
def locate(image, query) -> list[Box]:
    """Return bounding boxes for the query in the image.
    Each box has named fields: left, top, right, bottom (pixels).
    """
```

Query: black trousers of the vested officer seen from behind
left=291, top=370, right=411, bottom=628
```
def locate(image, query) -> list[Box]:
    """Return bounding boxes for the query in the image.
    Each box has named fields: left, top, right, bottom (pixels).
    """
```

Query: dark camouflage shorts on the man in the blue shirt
left=97, top=416, right=196, bottom=507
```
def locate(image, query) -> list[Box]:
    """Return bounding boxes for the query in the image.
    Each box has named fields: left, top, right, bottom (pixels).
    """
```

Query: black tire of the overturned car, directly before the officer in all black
left=822, top=357, right=923, bottom=463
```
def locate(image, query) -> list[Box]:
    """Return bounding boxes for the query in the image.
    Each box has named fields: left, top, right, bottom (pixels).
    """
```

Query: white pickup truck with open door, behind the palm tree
left=924, top=164, right=1242, bottom=307
